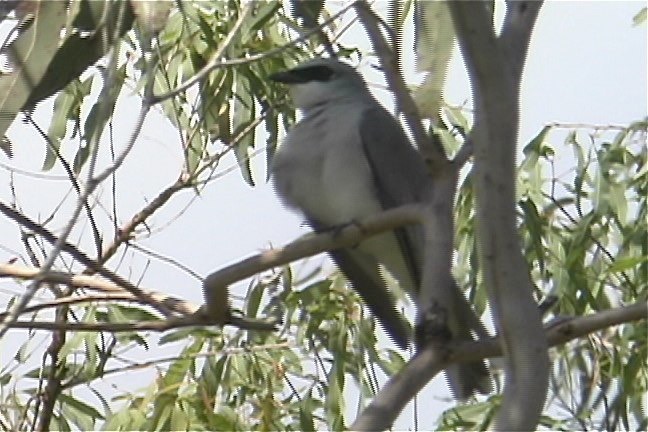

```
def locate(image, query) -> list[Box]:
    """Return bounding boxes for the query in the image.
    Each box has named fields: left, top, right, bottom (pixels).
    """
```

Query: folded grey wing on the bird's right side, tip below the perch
left=360, top=107, right=430, bottom=292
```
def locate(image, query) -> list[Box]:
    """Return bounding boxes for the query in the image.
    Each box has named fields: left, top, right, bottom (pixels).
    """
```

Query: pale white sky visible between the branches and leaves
left=0, top=1, right=648, bottom=429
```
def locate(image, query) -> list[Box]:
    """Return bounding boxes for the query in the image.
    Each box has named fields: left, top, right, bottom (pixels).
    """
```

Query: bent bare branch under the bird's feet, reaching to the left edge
left=0, top=202, right=424, bottom=331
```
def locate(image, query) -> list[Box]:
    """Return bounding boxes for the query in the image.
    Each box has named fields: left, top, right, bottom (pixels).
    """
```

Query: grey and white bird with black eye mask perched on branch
left=269, top=58, right=490, bottom=399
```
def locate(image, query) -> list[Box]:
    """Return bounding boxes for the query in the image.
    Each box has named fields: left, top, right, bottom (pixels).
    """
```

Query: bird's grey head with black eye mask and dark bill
left=269, top=58, right=369, bottom=109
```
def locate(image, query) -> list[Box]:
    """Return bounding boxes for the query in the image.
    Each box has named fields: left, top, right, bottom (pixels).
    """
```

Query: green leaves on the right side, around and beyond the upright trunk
left=450, top=119, right=648, bottom=430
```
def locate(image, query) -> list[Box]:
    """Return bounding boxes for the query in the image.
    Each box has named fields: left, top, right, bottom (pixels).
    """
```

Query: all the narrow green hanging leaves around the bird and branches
left=0, top=0, right=648, bottom=430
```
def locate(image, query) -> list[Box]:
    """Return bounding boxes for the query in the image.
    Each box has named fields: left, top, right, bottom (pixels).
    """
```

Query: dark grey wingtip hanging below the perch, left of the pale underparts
left=307, top=216, right=411, bottom=349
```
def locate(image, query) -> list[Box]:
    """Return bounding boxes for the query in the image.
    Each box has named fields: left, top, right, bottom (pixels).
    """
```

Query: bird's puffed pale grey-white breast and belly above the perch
left=273, top=104, right=381, bottom=225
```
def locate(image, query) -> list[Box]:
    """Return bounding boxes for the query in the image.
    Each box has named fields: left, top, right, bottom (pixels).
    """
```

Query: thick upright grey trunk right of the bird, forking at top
left=448, top=1, right=549, bottom=430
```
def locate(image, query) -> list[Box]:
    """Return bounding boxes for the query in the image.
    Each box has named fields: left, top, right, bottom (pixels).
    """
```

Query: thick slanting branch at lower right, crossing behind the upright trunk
left=350, top=302, right=648, bottom=431
